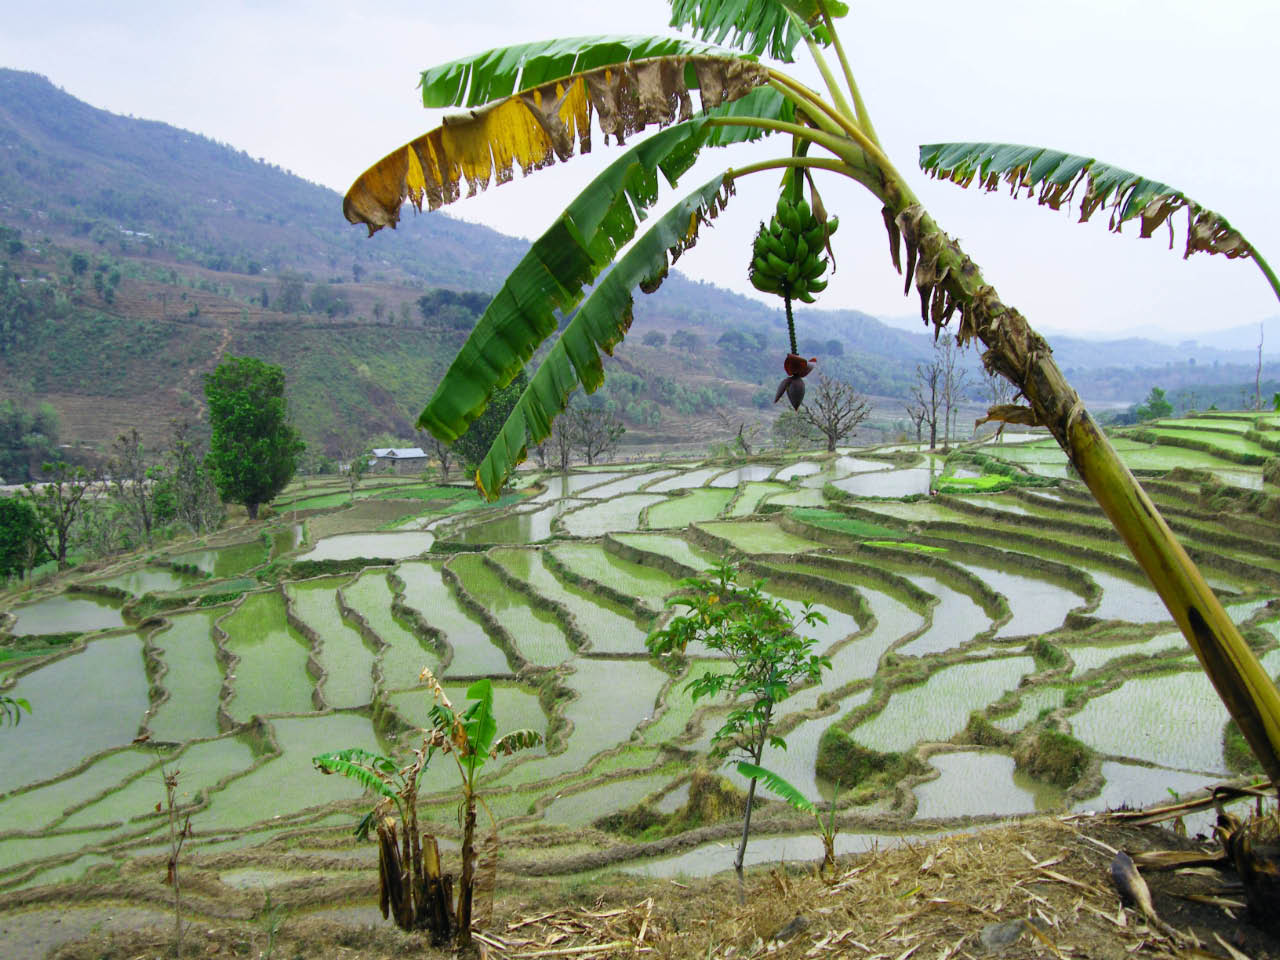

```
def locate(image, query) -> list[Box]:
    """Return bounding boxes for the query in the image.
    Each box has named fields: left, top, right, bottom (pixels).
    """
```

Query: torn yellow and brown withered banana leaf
left=343, top=55, right=768, bottom=234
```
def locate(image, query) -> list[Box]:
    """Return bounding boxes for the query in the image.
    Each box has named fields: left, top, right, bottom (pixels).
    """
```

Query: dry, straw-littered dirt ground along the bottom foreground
left=17, top=815, right=1280, bottom=960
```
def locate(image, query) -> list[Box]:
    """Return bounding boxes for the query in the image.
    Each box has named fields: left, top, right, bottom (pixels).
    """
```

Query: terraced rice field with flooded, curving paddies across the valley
left=0, top=419, right=1280, bottom=891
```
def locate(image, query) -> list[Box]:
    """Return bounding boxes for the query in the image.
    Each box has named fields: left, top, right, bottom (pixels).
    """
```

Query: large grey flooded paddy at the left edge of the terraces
left=0, top=634, right=150, bottom=790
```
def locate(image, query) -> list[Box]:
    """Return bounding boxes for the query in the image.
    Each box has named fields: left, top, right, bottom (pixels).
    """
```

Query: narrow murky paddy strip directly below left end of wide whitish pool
left=287, top=576, right=376, bottom=708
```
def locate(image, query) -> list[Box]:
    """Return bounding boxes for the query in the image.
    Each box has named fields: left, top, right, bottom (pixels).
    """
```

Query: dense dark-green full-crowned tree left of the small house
left=205, top=356, right=306, bottom=520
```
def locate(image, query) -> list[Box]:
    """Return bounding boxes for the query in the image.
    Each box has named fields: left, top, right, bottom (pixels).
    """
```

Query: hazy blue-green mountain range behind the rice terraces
left=0, top=69, right=1280, bottom=451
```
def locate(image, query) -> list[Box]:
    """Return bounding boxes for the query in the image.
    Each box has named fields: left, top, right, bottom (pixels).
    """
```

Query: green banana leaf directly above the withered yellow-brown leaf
left=420, top=36, right=736, bottom=106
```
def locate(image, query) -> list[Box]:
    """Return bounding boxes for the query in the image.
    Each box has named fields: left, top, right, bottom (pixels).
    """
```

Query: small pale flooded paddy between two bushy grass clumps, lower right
left=915, top=750, right=1065, bottom=818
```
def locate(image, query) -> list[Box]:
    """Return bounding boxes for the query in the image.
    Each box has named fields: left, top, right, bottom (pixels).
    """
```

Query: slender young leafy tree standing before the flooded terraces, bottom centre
left=645, top=559, right=831, bottom=874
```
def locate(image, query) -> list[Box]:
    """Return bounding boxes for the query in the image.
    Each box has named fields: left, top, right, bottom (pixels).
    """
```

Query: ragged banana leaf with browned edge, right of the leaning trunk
left=920, top=142, right=1259, bottom=267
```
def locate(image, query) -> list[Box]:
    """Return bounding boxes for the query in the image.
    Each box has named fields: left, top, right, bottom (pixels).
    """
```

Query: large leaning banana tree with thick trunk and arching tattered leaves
left=344, top=0, right=1280, bottom=781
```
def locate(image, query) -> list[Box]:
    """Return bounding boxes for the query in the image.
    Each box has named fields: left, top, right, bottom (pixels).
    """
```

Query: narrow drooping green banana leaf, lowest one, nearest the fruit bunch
left=473, top=174, right=726, bottom=500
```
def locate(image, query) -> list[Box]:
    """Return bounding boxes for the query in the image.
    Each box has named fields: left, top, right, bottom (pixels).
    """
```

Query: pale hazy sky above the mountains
left=0, top=0, right=1280, bottom=343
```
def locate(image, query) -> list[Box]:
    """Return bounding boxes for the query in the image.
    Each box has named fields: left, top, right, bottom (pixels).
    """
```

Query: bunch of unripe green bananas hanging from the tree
left=749, top=197, right=840, bottom=303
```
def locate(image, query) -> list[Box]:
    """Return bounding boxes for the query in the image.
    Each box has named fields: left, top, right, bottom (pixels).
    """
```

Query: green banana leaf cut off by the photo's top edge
left=671, top=0, right=849, bottom=63
